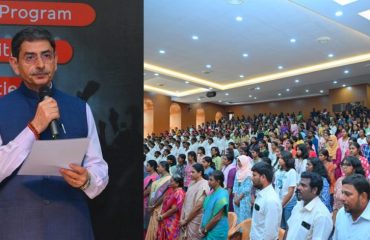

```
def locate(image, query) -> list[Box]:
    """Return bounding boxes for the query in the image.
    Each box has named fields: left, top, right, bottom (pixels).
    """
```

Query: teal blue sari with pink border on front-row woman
left=201, top=187, right=229, bottom=240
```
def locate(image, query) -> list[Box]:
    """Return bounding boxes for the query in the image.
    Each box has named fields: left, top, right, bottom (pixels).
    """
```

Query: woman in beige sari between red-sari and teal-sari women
left=180, top=163, right=210, bottom=240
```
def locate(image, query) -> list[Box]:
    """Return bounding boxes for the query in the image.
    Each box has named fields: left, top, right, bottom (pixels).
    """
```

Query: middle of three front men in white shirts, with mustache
left=285, top=172, right=333, bottom=240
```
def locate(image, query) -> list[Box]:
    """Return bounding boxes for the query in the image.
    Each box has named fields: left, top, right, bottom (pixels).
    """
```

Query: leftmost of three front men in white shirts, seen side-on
left=250, top=162, right=282, bottom=240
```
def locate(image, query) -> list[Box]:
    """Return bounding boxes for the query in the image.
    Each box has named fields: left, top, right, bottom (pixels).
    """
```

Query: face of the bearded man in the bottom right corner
left=341, top=184, right=361, bottom=213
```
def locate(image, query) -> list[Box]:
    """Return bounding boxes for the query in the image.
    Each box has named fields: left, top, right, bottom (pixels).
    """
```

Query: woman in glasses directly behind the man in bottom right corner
left=333, top=156, right=365, bottom=223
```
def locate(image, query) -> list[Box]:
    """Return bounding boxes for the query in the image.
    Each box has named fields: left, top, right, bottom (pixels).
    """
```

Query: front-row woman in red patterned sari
left=157, top=175, right=185, bottom=240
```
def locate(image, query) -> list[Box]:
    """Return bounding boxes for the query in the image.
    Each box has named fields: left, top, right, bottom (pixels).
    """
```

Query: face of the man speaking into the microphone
left=9, top=40, right=58, bottom=91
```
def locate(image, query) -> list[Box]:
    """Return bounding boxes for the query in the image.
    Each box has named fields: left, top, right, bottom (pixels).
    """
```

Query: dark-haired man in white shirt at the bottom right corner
left=333, top=174, right=370, bottom=240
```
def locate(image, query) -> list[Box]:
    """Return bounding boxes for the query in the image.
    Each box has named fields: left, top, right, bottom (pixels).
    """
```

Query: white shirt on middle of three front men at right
left=286, top=196, right=333, bottom=240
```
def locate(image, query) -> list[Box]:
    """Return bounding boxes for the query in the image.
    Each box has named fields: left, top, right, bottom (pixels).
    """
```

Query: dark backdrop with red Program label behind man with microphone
left=0, top=0, right=143, bottom=240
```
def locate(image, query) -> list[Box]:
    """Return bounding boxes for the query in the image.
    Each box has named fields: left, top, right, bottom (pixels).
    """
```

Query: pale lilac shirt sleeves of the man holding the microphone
left=0, top=104, right=109, bottom=198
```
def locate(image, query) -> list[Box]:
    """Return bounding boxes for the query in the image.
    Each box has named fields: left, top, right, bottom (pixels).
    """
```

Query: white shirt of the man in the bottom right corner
left=333, top=202, right=370, bottom=240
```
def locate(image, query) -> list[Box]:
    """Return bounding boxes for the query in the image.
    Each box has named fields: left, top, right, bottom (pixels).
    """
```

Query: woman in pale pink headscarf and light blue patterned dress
left=233, top=155, right=253, bottom=224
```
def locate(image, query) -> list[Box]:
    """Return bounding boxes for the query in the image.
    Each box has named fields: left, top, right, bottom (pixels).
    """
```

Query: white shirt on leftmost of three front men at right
left=250, top=184, right=282, bottom=240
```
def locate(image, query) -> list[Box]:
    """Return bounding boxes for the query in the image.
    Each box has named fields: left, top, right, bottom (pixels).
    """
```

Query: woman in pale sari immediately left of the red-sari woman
left=145, top=161, right=171, bottom=240
